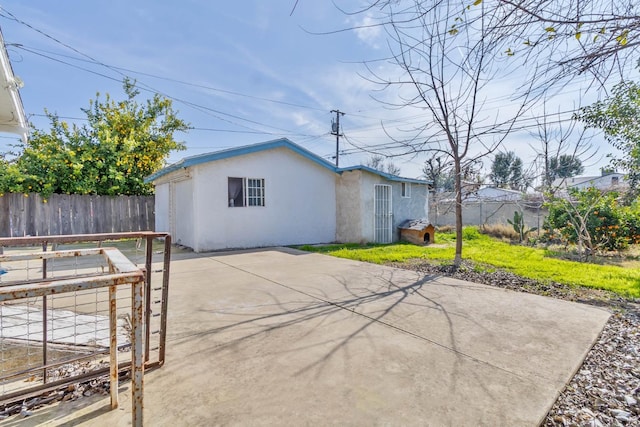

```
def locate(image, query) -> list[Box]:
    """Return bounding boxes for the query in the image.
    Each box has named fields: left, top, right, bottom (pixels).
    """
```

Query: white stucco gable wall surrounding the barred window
left=189, top=148, right=336, bottom=251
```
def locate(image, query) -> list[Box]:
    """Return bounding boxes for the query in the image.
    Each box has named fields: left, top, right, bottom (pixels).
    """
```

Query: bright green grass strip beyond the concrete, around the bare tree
left=300, top=227, right=640, bottom=298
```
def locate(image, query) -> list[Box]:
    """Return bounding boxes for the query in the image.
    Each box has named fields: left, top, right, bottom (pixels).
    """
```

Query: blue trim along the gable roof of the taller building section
left=144, top=138, right=337, bottom=183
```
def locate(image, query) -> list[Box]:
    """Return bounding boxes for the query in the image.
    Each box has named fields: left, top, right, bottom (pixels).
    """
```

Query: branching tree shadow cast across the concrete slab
left=170, top=268, right=516, bottom=402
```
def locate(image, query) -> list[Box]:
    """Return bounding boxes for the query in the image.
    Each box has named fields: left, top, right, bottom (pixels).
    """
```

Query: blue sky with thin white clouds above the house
left=0, top=0, right=624, bottom=178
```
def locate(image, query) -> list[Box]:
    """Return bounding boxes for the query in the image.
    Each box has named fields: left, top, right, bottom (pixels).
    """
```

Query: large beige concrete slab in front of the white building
left=22, top=248, right=609, bottom=426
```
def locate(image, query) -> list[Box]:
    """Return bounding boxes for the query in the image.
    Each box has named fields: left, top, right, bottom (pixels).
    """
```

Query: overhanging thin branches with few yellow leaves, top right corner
left=492, top=0, right=640, bottom=84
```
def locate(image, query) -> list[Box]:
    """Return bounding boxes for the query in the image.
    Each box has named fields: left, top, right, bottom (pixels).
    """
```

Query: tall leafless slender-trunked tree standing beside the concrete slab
left=352, top=0, right=532, bottom=265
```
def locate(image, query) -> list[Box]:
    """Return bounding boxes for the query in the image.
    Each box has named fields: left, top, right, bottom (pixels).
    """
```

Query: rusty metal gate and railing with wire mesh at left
left=0, top=232, right=171, bottom=425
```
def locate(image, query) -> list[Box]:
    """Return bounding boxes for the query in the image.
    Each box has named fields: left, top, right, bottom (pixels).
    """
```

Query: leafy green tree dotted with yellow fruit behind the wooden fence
left=5, top=80, right=188, bottom=196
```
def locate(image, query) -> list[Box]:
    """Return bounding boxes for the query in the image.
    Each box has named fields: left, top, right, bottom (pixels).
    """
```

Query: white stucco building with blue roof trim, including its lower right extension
left=146, top=139, right=428, bottom=252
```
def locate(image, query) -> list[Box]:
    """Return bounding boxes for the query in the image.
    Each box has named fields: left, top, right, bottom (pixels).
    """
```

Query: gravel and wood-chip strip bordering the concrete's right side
left=390, top=261, right=640, bottom=427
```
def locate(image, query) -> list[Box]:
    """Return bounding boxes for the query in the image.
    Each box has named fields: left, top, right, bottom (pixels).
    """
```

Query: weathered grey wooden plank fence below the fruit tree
left=0, top=193, right=155, bottom=237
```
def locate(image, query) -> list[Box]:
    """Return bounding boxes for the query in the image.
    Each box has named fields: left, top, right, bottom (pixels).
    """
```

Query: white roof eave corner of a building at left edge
left=0, top=28, right=29, bottom=141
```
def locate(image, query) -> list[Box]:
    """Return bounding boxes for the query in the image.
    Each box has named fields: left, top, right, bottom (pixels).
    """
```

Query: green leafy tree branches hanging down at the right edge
left=577, top=82, right=640, bottom=202
